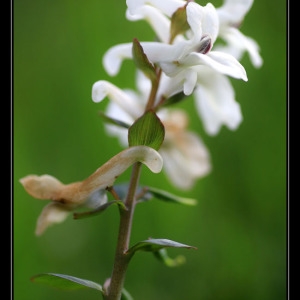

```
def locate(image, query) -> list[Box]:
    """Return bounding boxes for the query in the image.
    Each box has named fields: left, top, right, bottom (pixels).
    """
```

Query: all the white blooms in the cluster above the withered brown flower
left=92, top=0, right=262, bottom=189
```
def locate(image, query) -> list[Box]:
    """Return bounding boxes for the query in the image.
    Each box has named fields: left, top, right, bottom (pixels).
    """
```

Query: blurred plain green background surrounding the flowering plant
left=13, top=0, right=287, bottom=300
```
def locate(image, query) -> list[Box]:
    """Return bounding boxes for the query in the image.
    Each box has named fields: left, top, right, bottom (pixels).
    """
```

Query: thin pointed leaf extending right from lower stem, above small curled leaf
left=127, top=239, right=197, bottom=256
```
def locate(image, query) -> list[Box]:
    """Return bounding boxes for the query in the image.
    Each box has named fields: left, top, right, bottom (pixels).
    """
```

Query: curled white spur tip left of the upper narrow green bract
left=103, top=43, right=132, bottom=76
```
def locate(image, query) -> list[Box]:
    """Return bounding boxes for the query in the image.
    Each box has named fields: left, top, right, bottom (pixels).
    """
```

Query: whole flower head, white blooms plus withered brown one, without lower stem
left=20, top=0, right=262, bottom=235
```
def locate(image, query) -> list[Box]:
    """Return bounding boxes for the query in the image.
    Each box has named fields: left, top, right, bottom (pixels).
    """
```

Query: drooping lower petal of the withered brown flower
left=35, top=202, right=70, bottom=236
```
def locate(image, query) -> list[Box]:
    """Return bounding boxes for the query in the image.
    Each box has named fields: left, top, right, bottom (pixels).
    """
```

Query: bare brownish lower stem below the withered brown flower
left=104, top=162, right=142, bottom=300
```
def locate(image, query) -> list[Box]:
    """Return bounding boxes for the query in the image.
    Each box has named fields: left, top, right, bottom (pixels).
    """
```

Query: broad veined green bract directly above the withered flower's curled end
left=128, top=110, right=165, bottom=150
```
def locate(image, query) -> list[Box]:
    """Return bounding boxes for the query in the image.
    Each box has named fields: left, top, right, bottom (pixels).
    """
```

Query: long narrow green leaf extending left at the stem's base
left=30, top=273, right=103, bottom=292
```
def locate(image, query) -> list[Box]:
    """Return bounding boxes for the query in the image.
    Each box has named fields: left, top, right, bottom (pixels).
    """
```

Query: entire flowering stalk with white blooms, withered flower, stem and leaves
left=20, top=0, right=262, bottom=300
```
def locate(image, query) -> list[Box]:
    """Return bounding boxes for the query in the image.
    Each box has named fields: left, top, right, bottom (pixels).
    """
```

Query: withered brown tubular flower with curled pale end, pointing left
left=20, top=146, right=162, bottom=235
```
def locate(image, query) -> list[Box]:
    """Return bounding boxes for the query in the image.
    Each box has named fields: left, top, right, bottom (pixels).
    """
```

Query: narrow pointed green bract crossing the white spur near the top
left=132, top=39, right=157, bottom=82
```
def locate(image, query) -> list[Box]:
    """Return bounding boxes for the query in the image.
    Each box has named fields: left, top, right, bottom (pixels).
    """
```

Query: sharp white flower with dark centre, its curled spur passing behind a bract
left=103, top=2, right=248, bottom=95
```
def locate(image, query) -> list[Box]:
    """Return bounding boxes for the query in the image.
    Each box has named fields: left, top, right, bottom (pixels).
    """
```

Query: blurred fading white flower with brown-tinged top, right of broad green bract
left=159, top=109, right=211, bottom=189
